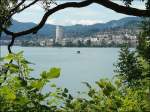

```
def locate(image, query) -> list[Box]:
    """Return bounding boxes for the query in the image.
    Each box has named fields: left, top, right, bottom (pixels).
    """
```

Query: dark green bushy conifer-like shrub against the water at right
left=115, top=46, right=144, bottom=86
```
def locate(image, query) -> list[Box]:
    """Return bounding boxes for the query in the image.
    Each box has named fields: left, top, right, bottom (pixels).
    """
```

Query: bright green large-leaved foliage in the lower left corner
left=0, top=52, right=60, bottom=112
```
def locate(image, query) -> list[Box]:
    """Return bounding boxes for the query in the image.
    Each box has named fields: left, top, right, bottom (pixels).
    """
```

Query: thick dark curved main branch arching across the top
left=4, top=0, right=150, bottom=37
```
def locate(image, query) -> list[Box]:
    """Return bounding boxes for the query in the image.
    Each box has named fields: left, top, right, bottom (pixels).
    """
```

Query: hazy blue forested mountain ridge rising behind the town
left=1, top=17, right=142, bottom=38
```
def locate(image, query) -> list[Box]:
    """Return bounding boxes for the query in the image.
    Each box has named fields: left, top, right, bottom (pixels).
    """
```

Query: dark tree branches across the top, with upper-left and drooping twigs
left=0, top=0, right=150, bottom=84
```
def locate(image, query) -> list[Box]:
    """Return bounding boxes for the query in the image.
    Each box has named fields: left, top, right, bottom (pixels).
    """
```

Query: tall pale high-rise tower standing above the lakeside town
left=55, top=26, right=64, bottom=43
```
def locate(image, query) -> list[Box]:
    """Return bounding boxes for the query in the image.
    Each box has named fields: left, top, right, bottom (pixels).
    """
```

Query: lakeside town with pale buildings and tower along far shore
left=0, top=26, right=139, bottom=47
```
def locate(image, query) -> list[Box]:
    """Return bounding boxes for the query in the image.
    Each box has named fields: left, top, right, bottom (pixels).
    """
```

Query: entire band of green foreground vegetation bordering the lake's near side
left=0, top=19, right=150, bottom=112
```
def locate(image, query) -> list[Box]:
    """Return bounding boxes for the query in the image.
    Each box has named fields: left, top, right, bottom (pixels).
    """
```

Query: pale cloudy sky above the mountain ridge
left=13, top=0, right=145, bottom=26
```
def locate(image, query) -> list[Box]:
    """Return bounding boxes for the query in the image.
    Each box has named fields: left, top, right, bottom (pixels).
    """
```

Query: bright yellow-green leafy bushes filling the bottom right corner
left=61, top=80, right=150, bottom=112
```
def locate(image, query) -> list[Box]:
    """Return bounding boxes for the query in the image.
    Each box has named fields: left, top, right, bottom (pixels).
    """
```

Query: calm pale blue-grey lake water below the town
left=1, top=46, right=119, bottom=93
